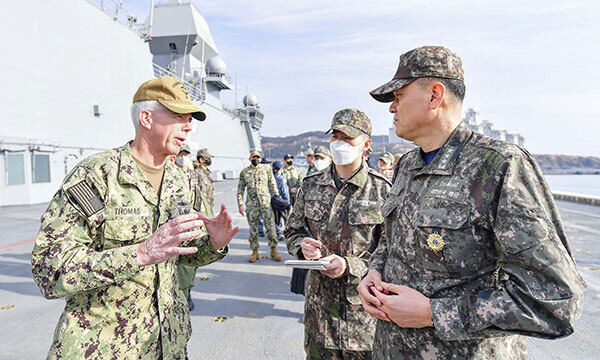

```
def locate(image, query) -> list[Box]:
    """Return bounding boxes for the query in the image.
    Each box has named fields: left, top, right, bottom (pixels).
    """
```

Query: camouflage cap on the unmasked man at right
left=370, top=46, right=465, bottom=102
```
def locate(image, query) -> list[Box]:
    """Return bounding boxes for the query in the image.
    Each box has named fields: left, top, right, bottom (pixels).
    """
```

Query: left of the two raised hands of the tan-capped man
left=137, top=213, right=204, bottom=266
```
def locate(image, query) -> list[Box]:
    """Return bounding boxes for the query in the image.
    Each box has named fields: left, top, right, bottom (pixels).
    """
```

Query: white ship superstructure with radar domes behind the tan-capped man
left=0, top=0, right=263, bottom=206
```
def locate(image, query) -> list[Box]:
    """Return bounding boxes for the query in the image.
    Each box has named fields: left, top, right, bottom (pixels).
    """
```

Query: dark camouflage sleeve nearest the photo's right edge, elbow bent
left=431, top=154, right=585, bottom=340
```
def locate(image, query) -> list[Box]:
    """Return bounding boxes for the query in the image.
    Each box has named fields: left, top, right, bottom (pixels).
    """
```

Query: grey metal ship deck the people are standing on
left=0, top=181, right=600, bottom=360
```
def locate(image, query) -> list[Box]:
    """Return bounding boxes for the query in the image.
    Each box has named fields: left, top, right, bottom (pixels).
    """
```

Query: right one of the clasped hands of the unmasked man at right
left=372, top=282, right=433, bottom=328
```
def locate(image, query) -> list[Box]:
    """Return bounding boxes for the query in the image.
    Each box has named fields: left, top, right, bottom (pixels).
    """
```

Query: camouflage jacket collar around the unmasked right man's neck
left=411, top=122, right=473, bottom=175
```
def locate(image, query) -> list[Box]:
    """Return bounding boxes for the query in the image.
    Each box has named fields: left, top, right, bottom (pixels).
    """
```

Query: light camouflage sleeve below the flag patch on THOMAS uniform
left=31, top=171, right=139, bottom=299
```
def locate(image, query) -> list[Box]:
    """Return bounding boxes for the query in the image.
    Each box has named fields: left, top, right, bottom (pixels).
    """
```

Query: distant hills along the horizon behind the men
left=262, top=131, right=600, bottom=173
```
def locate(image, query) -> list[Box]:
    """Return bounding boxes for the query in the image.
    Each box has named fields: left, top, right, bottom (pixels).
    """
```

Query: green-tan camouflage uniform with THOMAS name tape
left=31, top=144, right=226, bottom=359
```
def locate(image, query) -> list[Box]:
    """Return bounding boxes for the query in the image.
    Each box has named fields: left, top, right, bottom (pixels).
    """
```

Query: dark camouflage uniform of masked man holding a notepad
left=285, top=163, right=390, bottom=359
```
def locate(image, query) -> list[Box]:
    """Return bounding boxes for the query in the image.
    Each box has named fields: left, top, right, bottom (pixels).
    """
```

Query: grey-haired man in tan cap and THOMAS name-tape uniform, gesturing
left=31, top=77, right=239, bottom=360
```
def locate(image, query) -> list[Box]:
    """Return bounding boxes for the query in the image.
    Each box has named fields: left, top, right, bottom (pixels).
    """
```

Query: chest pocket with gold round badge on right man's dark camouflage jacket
left=413, top=198, right=495, bottom=277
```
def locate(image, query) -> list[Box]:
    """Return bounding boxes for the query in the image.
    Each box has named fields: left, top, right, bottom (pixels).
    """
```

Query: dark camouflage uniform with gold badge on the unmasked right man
left=371, top=124, right=585, bottom=359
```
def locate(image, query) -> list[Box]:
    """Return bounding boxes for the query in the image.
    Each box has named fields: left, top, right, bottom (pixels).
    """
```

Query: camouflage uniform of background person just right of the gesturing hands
left=237, top=164, right=279, bottom=250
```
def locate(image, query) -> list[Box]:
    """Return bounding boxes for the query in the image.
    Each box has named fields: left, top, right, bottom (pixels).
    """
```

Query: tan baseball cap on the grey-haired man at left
left=133, top=76, right=206, bottom=121
